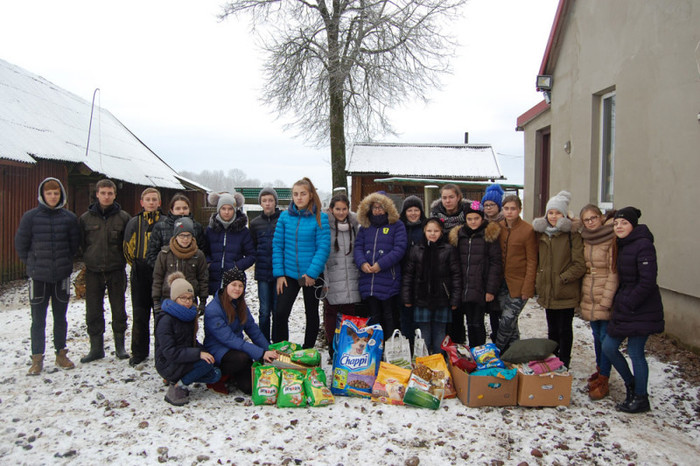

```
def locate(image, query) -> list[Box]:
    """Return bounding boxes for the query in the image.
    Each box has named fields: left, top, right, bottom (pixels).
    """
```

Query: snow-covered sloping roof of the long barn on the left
left=0, top=60, right=184, bottom=189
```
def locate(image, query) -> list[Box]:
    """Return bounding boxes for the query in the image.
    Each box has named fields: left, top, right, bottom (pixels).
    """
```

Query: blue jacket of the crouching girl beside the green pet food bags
left=204, top=293, right=270, bottom=364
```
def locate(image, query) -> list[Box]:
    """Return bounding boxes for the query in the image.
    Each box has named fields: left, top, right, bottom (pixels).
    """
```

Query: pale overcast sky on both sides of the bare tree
left=0, top=0, right=558, bottom=191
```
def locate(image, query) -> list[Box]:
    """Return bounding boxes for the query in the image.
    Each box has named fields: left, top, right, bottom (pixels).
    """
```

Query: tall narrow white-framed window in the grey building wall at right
left=598, top=92, right=615, bottom=209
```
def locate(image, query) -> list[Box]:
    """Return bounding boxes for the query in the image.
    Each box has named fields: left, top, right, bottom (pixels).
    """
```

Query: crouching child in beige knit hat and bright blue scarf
left=156, top=272, right=221, bottom=406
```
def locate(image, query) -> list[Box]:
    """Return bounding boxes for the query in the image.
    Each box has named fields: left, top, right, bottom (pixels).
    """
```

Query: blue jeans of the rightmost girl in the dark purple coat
left=603, top=335, right=649, bottom=395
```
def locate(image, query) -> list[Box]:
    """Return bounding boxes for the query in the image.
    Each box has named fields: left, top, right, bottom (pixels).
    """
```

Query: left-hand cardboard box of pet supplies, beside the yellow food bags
left=449, top=358, right=518, bottom=408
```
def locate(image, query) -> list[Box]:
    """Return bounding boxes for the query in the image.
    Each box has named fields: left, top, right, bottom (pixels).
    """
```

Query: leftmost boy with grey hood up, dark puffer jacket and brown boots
left=15, top=178, right=80, bottom=375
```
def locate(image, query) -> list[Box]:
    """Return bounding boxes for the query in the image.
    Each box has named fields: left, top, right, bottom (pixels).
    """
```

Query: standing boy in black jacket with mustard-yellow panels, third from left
left=124, top=188, right=162, bottom=366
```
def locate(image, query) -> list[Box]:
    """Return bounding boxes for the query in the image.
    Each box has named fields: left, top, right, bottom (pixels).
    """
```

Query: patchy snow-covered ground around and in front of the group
left=0, top=273, right=700, bottom=465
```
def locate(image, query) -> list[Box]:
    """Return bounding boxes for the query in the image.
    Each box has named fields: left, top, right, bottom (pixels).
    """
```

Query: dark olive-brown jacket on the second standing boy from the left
left=80, top=202, right=131, bottom=272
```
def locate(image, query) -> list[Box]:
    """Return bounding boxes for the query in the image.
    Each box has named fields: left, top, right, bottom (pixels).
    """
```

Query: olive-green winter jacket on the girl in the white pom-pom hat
left=532, top=217, right=586, bottom=309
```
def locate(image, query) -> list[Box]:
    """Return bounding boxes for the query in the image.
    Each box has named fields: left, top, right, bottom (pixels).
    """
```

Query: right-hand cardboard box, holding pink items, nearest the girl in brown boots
left=518, top=372, right=572, bottom=406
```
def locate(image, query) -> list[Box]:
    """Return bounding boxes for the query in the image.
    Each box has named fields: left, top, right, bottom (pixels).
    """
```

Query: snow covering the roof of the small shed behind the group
left=346, top=143, right=503, bottom=180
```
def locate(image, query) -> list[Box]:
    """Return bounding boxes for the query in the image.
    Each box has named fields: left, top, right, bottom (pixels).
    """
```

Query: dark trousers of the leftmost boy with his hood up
left=29, top=278, right=70, bottom=354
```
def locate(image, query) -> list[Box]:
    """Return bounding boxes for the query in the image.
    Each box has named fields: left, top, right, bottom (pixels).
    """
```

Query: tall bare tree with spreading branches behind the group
left=220, top=0, right=466, bottom=187
